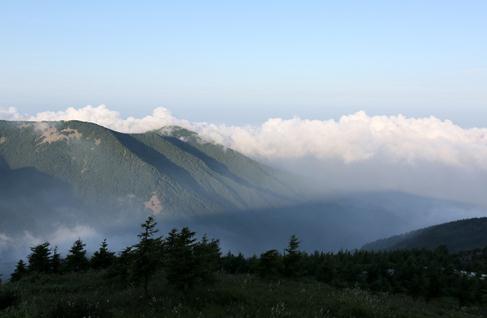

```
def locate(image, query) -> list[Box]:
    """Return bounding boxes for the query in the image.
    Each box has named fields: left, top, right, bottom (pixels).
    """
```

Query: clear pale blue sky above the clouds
left=0, top=0, right=487, bottom=127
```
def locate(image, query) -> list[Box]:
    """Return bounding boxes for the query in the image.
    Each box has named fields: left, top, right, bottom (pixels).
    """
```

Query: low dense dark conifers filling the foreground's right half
left=221, top=243, right=487, bottom=305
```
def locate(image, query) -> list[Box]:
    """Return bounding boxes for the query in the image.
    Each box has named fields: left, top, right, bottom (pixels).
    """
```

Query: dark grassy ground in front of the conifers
left=0, top=272, right=485, bottom=318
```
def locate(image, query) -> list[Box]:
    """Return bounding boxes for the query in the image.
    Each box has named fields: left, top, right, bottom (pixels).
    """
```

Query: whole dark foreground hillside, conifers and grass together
left=0, top=217, right=487, bottom=317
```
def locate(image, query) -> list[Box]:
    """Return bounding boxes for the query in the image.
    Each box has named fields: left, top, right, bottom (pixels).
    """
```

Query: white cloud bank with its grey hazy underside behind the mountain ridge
left=0, top=105, right=487, bottom=206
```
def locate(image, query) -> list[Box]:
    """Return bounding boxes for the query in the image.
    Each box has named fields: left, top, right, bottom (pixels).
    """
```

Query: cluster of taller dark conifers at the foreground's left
left=11, top=217, right=220, bottom=295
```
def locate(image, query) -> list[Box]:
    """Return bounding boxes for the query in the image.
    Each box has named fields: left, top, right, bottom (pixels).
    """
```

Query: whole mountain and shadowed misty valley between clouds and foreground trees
left=0, top=121, right=486, bottom=271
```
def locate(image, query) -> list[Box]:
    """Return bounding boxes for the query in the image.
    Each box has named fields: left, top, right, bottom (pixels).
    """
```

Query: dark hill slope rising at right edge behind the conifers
left=363, top=217, right=487, bottom=251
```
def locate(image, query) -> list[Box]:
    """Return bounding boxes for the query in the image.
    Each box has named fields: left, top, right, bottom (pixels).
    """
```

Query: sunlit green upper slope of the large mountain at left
left=0, top=121, right=295, bottom=215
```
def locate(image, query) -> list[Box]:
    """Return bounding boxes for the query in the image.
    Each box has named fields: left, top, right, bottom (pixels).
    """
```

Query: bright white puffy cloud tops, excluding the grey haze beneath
left=0, top=105, right=487, bottom=170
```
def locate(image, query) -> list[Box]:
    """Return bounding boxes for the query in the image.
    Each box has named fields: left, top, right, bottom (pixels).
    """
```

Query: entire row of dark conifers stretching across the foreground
left=11, top=217, right=487, bottom=305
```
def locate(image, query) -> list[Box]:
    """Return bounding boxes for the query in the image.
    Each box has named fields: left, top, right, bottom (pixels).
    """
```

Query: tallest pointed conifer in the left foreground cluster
left=133, top=216, right=161, bottom=296
